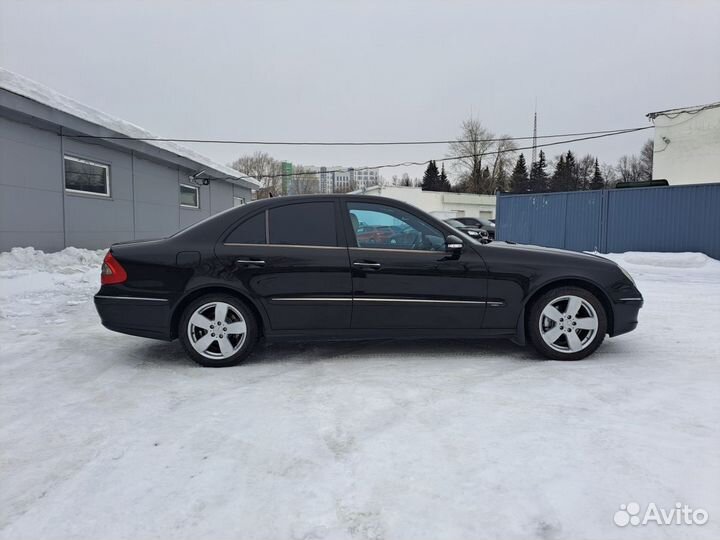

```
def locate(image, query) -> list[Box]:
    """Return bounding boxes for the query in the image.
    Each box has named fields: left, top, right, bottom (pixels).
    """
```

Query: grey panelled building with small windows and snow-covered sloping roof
left=0, top=68, right=260, bottom=251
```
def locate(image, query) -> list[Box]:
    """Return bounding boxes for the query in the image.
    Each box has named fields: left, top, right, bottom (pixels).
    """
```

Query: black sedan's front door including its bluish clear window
left=343, top=200, right=487, bottom=329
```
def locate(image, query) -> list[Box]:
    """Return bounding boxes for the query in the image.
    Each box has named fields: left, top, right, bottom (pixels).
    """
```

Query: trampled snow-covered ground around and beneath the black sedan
left=0, top=249, right=720, bottom=540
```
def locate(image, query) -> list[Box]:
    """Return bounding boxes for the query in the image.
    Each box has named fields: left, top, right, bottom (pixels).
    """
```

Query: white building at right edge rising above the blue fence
left=647, top=101, right=720, bottom=186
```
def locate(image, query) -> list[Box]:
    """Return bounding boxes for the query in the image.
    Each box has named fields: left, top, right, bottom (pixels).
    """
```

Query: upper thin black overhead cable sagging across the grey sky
left=69, top=126, right=653, bottom=146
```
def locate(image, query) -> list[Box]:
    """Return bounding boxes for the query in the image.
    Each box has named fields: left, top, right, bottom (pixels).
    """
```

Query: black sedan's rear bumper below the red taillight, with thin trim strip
left=95, top=294, right=172, bottom=341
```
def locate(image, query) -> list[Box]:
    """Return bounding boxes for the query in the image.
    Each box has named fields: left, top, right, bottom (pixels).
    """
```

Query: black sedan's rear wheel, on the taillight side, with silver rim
left=178, top=294, right=258, bottom=367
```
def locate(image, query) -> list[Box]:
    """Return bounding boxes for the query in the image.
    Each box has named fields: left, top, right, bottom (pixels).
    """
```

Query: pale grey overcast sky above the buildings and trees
left=0, top=0, right=720, bottom=178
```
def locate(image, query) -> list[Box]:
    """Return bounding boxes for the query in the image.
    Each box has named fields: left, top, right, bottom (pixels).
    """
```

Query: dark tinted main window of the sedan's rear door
left=268, top=201, right=337, bottom=246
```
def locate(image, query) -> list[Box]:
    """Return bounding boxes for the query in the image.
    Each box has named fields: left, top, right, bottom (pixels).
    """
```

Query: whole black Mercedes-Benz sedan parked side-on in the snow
left=95, top=195, right=643, bottom=367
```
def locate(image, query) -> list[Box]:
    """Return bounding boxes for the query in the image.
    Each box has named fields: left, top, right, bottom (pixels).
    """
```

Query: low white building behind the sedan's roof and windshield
left=354, top=185, right=495, bottom=219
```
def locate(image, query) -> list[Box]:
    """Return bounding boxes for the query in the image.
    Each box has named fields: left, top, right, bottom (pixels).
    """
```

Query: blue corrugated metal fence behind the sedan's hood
left=497, top=183, right=720, bottom=259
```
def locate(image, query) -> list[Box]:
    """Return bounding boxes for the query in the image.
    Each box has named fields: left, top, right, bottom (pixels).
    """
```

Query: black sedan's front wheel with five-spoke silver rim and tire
left=527, top=287, right=607, bottom=360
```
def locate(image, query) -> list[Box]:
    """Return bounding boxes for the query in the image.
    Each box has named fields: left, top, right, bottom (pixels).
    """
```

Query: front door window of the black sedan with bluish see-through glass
left=348, top=203, right=445, bottom=251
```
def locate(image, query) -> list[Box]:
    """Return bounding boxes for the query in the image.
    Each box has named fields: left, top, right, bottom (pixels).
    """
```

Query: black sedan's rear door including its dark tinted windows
left=215, top=199, right=352, bottom=331
